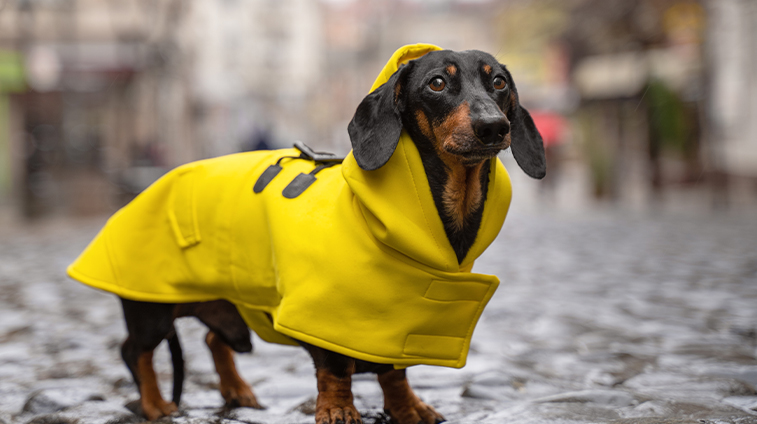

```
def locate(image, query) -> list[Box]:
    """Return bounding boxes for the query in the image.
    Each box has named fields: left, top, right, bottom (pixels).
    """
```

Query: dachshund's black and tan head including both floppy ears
left=348, top=50, right=546, bottom=178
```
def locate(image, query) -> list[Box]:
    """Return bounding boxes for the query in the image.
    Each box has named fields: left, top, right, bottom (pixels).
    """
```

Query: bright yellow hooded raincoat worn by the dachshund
left=68, top=45, right=510, bottom=368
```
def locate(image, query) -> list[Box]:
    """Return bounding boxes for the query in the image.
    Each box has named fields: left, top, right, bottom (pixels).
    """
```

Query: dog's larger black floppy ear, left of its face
left=347, top=62, right=412, bottom=171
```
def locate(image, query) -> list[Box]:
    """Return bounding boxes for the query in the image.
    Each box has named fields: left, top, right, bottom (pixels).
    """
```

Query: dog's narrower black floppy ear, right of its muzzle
left=502, top=66, right=547, bottom=179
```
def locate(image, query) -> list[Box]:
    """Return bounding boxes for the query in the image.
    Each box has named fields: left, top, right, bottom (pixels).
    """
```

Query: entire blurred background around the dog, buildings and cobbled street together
left=0, top=0, right=757, bottom=424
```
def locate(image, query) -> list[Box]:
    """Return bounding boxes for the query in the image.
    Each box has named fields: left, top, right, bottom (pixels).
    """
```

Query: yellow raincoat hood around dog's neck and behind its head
left=342, top=44, right=511, bottom=271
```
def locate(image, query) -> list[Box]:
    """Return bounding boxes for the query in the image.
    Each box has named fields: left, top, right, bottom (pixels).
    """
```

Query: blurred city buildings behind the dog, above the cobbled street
left=0, top=0, right=757, bottom=217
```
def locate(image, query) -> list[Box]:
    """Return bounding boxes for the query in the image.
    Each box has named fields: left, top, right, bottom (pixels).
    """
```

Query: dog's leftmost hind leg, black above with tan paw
left=121, top=299, right=183, bottom=420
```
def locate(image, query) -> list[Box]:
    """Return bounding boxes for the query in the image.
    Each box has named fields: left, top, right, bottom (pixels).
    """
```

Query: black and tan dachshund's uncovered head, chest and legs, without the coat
left=71, top=44, right=545, bottom=424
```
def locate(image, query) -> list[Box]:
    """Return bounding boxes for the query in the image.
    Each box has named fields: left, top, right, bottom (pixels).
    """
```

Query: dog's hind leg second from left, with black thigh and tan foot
left=179, top=300, right=264, bottom=409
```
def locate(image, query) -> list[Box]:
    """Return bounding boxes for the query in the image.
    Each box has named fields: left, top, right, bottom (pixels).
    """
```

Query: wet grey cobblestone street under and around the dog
left=0, top=203, right=757, bottom=424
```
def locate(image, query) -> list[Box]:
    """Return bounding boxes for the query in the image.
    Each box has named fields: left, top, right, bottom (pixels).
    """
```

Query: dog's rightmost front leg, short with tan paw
left=378, top=370, right=444, bottom=424
